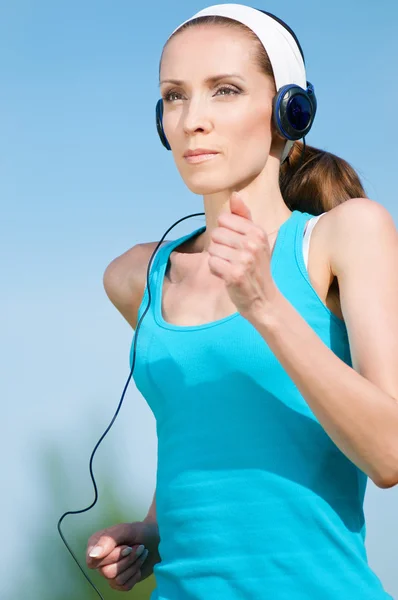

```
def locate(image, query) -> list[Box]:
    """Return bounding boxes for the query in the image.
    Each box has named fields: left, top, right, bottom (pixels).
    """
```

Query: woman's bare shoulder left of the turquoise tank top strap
left=103, top=240, right=168, bottom=329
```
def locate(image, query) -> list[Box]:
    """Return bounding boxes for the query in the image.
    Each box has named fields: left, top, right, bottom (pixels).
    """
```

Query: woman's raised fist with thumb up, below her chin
left=208, top=192, right=278, bottom=319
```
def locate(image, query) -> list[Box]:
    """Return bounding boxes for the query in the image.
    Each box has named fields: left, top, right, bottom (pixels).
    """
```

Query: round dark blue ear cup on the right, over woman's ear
left=273, top=81, right=317, bottom=141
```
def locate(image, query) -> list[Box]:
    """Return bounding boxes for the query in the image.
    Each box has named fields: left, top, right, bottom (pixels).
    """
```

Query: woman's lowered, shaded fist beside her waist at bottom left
left=86, top=521, right=161, bottom=592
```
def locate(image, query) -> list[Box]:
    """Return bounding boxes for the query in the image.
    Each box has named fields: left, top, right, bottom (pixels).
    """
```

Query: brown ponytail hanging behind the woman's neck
left=279, top=142, right=366, bottom=215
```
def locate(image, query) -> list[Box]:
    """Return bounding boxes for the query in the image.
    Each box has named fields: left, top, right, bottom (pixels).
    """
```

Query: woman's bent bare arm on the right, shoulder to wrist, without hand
left=251, top=198, right=398, bottom=489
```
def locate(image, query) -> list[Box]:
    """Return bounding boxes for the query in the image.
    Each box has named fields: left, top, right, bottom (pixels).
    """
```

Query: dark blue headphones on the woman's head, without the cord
left=156, top=8, right=317, bottom=150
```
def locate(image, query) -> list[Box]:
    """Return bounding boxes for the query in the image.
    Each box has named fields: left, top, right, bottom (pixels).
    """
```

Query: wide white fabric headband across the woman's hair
left=166, top=4, right=307, bottom=162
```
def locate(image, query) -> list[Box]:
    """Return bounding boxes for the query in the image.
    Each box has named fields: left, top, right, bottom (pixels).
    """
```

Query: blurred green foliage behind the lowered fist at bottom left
left=10, top=438, right=156, bottom=600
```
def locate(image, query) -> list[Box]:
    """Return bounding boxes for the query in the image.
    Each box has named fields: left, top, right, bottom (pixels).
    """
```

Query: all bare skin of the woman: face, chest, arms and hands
left=86, top=19, right=398, bottom=591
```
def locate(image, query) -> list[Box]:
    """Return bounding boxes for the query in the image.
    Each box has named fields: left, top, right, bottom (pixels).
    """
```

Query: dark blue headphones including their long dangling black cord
left=57, top=9, right=317, bottom=600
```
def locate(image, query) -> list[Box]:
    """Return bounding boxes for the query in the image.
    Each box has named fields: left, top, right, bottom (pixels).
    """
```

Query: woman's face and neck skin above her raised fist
left=160, top=26, right=291, bottom=254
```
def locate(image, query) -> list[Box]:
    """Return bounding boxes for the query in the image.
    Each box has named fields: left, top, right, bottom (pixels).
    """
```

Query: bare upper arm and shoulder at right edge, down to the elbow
left=321, top=198, right=398, bottom=434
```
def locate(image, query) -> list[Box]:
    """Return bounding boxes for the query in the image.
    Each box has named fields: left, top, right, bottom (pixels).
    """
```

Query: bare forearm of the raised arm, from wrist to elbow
left=248, top=293, right=398, bottom=487
